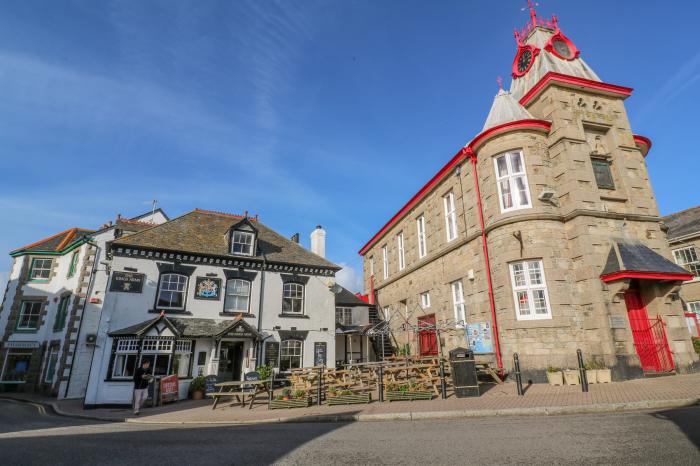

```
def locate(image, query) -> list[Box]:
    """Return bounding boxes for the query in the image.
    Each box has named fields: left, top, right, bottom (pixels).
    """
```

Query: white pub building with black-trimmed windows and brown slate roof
left=85, top=209, right=340, bottom=407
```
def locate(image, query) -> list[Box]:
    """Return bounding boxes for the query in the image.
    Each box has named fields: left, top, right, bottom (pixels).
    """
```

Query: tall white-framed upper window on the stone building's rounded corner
left=493, top=150, right=532, bottom=212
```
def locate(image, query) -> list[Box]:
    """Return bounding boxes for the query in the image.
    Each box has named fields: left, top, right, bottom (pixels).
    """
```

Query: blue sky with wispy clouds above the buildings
left=0, top=0, right=700, bottom=288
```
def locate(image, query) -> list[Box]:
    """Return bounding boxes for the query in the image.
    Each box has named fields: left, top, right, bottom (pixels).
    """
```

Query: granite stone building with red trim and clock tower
left=360, top=9, right=698, bottom=380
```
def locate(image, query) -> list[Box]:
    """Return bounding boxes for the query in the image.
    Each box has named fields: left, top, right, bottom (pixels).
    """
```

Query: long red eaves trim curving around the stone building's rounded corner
left=359, top=119, right=552, bottom=255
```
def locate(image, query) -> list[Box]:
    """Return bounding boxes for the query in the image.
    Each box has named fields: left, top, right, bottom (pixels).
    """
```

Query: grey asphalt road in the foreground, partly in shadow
left=0, top=401, right=700, bottom=465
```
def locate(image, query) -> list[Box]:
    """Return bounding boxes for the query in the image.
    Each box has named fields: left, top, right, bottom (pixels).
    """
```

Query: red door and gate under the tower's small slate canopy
left=625, top=290, right=674, bottom=372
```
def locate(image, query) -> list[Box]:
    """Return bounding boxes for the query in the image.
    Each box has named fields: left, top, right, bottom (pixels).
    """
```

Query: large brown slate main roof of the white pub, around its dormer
left=112, top=209, right=340, bottom=270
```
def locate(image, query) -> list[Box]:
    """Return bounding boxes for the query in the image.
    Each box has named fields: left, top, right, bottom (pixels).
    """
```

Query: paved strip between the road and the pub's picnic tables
left=17, top=374, right=700, bottom=423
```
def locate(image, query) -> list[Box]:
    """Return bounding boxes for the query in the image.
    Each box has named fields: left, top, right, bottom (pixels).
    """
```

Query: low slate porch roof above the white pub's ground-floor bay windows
left=109, top=316, right=261, bottom=338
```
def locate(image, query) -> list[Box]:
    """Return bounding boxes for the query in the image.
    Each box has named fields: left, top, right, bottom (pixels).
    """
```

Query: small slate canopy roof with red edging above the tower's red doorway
left=601, top=240, right=688, bottom=275
